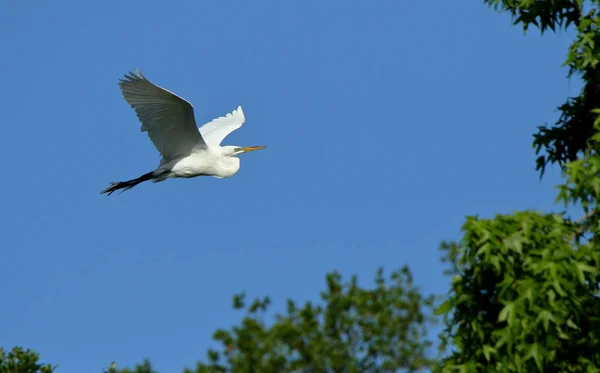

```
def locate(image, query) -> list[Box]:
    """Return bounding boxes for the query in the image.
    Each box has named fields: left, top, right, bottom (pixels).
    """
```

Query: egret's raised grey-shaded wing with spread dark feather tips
left=119, top=70, right=206, bottom=161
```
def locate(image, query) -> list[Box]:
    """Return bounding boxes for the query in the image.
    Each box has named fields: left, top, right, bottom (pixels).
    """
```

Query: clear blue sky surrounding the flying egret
left=0, top=0, right=579, bottom=373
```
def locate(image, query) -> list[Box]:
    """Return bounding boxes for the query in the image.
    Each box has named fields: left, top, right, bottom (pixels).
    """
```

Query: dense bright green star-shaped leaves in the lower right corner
left=436, top=211, right=600, bottom=372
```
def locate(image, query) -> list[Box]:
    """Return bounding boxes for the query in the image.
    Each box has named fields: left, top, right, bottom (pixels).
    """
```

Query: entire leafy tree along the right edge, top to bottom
left=438, top=0, right=600, bottom=372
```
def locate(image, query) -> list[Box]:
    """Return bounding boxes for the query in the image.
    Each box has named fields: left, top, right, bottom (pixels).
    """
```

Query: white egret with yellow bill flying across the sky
left=100, top=70, right=265, bottom=195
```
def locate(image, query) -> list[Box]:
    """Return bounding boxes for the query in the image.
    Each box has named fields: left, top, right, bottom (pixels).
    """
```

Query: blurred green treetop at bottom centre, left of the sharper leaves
left=185, top=268, right=433, bottom=373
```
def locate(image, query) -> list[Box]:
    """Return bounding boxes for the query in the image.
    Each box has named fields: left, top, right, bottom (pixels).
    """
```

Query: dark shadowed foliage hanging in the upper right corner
left=484, top=0, right=600, bottom=175
